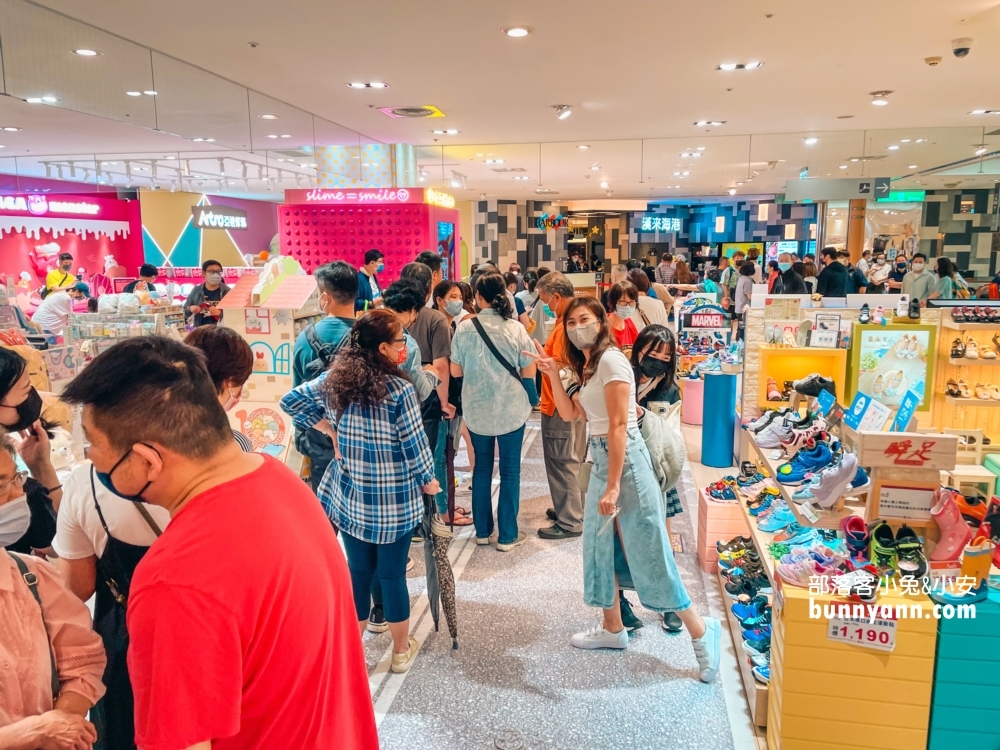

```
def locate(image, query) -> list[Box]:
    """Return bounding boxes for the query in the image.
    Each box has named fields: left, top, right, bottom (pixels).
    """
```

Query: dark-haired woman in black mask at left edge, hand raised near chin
left=0, top=348, right=62, bottom=554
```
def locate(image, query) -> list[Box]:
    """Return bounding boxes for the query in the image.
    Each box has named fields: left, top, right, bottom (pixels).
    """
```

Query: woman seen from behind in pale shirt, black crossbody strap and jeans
left=451, top=273, right=535, bottom=552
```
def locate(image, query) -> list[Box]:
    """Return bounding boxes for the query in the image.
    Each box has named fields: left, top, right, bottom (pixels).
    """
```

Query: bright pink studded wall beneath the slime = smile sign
left=278, top=203, right=434, bottom=283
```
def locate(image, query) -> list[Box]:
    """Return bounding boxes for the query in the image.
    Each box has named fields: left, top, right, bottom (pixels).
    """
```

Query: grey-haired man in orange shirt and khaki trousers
left=535, top=271, right=587, bottom=539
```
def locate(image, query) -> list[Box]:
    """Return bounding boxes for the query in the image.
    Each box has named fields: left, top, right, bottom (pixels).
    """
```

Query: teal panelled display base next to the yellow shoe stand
left=927, top=590, right=1000, bottom=750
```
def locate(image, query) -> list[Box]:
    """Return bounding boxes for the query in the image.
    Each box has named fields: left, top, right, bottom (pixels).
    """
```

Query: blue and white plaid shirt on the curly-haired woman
left=281, top=372, right=434, bottom=544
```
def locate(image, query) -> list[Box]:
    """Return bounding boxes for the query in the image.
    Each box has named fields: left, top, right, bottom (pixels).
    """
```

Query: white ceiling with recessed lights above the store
left=7, top=0, right=1000, bottom=198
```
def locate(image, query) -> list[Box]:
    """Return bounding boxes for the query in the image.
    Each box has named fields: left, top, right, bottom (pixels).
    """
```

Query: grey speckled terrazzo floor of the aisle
left=365, top=415, right=761, bottom=750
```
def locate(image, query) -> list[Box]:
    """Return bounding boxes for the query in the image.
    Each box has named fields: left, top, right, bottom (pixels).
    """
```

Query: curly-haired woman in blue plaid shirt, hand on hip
left=281, top=310, right=440, bottom=672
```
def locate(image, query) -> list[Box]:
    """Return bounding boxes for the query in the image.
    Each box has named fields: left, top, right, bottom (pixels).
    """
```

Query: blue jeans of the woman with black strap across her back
left=469, top=425, right=524, bottom=544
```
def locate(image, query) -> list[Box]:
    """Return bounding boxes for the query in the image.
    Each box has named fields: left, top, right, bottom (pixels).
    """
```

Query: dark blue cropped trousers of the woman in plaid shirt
left=340, top=532, right=413, bottom=622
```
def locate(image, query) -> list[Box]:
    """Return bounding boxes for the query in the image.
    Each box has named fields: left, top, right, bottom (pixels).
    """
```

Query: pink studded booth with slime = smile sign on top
left=278, top=188, right=458, bottom=285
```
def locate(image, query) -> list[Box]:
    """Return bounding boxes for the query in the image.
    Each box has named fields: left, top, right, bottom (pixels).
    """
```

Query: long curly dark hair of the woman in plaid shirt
left=321, top=310, right=409, bottom=411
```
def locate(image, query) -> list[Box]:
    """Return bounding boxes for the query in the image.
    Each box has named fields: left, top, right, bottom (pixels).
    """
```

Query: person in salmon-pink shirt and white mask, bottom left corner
left=0, top=436, right=106, bottom=750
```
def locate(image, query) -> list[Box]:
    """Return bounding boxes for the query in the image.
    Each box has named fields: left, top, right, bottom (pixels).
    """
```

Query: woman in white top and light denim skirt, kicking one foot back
left=536, top=297, right=722, bottom=682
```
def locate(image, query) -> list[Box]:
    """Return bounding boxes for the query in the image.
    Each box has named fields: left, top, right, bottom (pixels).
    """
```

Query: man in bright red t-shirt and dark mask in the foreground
left=63, top=336, right=378, bottom=750
